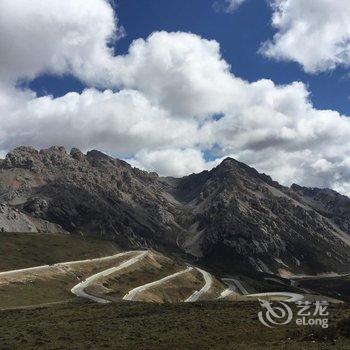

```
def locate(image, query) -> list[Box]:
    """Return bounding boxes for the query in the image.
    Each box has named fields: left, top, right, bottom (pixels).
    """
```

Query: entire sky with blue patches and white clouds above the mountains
left=0, top=0, right=350, bottom=195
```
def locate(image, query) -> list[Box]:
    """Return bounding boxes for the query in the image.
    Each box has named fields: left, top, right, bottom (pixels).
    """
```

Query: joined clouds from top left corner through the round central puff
left=0, top=0, right=238, bottom=116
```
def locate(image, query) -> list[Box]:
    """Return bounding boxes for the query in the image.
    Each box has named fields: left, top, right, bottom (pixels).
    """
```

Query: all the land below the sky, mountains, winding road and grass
left=0, top=147, right=350, bottom=350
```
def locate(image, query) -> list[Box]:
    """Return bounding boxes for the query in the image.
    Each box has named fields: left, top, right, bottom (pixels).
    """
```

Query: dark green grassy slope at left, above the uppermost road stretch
left=0, top=233, right=116, bottom=271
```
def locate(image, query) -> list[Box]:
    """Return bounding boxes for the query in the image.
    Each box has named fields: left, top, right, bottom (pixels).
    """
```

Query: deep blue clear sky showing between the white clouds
left=29, top=0, right=350, bottom=115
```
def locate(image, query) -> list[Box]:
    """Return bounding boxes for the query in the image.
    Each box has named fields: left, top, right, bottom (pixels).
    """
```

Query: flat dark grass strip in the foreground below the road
left=0, top=302, right=350, bottom=350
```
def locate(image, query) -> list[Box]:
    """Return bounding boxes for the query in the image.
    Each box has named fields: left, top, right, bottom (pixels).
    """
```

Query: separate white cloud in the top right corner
left=261, top=0, right=350, bottom=73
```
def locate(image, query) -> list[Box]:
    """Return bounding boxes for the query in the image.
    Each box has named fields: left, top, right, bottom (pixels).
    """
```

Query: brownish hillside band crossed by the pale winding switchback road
left=0, top=233, right=349, bottom=309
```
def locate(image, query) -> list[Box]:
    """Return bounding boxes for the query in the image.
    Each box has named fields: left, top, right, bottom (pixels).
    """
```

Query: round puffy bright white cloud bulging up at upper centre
left=105, top=32, right=239, bottom=117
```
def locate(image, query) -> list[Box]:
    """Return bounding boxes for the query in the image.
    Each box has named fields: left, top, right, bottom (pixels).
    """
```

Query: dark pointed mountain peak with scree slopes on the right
left=170, top=159, right=349, bottom=273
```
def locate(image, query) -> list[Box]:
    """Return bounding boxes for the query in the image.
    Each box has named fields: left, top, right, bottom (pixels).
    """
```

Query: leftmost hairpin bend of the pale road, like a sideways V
left=71, top=251, right=148, bottom=304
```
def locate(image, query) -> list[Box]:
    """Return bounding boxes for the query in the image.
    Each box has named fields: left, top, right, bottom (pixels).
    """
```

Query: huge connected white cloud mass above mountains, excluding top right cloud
left=0, top=0, right=350, bottom=194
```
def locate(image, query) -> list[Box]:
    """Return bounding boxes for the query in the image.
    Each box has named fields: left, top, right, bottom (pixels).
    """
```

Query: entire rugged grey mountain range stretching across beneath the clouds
left=0, top=147, right=350, bottom=275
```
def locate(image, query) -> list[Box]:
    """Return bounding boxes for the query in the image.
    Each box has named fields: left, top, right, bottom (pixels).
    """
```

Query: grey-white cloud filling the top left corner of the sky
left=0, top=0, right=118, bottom=82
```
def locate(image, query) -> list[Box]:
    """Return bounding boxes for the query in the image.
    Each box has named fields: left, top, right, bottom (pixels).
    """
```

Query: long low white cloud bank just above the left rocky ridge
left=0, top=89, right=199, bottom=157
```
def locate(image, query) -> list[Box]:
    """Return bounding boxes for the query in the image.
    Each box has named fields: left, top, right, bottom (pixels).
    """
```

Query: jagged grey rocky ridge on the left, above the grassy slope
left=0, top=147, right=180, bottom=249
